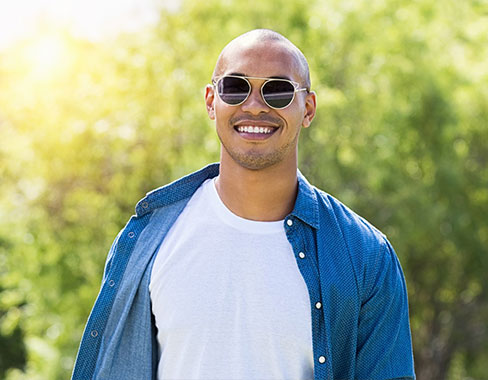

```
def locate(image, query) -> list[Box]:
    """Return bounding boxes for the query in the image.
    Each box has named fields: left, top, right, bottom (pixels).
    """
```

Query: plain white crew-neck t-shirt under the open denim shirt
left=149, top=180, right=313, bottom=380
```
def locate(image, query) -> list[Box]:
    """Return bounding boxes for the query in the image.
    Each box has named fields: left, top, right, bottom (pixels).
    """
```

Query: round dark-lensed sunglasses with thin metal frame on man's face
left=212, top=75, right=308, bottom=109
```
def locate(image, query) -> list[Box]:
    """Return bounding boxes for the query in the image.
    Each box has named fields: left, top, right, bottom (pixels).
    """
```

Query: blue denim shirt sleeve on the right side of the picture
left=355, top=239, right=415, bottom=380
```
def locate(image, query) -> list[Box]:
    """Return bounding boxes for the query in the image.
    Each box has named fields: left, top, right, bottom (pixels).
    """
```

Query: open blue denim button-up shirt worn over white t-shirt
left=72, top=164, right=415, bottom=380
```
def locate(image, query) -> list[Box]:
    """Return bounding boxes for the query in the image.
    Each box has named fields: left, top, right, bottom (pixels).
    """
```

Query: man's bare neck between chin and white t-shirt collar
left=216, top=154, right=298, bottom=221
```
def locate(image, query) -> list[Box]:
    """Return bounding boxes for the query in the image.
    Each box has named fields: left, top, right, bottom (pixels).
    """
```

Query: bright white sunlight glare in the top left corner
left=0, top=0, right=168, bottom=51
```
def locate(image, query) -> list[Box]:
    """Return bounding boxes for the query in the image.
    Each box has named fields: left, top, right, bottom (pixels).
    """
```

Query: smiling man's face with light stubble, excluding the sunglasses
left=205, top=41, right=315, bottom=170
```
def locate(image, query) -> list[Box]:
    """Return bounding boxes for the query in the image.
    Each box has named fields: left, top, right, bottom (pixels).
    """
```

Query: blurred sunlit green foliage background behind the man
left=0, top=0, right=488, bottom=380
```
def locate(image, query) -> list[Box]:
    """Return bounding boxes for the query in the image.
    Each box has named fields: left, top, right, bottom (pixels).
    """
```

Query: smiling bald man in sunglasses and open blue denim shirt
left=73, top=30, right=415, bottom=380
